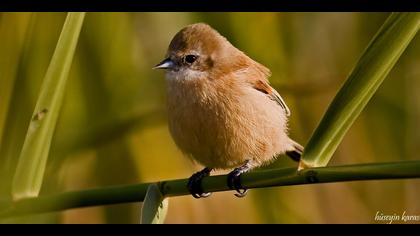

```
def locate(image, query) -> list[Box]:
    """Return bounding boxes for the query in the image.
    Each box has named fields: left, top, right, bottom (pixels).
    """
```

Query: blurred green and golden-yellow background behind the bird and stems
left=0, top=13, right=420, bottom=223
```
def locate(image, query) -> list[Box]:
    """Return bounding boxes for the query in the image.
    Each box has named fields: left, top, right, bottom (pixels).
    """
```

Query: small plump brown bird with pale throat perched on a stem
left=154, top=23, right=303, bottom=198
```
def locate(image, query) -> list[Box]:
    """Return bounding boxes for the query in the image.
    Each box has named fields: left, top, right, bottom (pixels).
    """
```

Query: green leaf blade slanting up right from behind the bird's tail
left=299, top=12, right=420, bottom=169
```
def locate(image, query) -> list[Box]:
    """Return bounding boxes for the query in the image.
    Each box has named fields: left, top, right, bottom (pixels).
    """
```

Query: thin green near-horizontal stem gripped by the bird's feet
left=0, top=161, right=420, bottom=218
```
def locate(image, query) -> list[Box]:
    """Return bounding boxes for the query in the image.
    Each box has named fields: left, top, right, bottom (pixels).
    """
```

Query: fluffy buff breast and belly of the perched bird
left=168, top=79, right=289, bottom=169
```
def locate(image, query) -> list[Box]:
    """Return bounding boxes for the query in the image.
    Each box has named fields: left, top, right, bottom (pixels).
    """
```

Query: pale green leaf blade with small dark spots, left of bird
left=12, top=12, right=85, bottom=199
